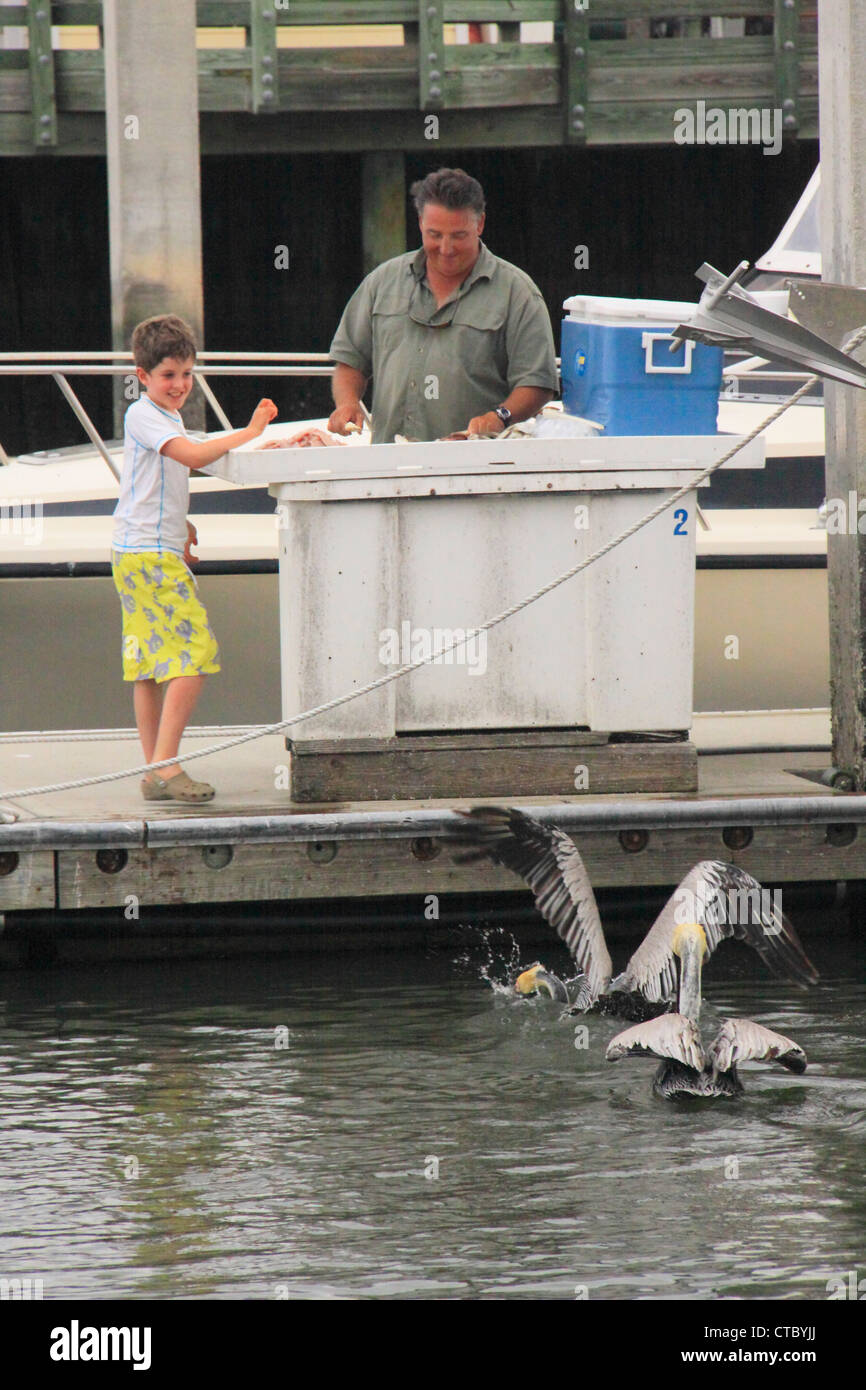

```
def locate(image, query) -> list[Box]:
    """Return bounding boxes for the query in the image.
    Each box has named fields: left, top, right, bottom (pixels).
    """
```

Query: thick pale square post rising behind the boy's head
left=103, top=0, right=204, bottom=432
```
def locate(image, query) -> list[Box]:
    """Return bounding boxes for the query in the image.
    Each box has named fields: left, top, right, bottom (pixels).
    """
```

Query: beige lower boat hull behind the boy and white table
left=0, top=564, right=830, bottom=733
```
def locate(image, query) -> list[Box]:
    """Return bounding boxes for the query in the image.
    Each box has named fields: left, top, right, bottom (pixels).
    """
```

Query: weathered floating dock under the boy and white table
left=0, top=735, right=866, bottom=954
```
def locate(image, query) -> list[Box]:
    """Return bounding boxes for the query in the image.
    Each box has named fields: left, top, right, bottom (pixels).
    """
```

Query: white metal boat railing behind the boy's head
left=0, top=349, right=334, bottom=481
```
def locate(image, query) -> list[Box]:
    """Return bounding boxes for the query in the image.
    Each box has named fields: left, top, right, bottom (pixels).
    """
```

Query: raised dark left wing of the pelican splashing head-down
left=450, top=806, right=613, bottom=999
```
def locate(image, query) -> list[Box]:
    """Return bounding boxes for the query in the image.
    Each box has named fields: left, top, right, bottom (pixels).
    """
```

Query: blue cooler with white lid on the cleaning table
left=562, top=295, right=723, bottom=435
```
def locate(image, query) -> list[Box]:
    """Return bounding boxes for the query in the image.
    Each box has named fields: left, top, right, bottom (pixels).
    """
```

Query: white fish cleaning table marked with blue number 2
left=209, top=425, right=765, bottom=802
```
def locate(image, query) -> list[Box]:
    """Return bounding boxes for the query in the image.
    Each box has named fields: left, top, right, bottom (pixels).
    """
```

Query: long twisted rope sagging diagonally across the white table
left=0, top=336, right=866, bottom=801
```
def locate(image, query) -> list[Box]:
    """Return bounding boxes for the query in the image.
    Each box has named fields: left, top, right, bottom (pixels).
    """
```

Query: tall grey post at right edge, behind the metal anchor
left=819, top=0, right=866, bottom=791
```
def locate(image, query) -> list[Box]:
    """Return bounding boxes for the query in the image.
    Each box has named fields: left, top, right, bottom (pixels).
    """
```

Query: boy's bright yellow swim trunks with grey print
left=111, top=550, right=220, bottom=681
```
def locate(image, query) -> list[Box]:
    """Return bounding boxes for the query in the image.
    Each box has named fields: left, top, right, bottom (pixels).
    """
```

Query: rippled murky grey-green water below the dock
left=0, top=917, right=866, bottom=1300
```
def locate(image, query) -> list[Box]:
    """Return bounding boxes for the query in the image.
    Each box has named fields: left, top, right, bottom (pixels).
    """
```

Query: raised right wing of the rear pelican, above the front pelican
left=620, top=859, right=817, bottom=1002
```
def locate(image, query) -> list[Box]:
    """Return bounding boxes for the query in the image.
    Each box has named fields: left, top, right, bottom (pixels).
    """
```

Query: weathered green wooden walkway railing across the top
left=0, top=0, right=817, bottom=153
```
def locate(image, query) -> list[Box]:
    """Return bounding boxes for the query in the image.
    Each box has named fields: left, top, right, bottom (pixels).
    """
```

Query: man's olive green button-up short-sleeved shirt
left=331, top=243, right=557, bottom=443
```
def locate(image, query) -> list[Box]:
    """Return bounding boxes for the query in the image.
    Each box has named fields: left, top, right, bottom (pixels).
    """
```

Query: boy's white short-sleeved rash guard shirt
left=111, top=396, right=189, bottom=555
